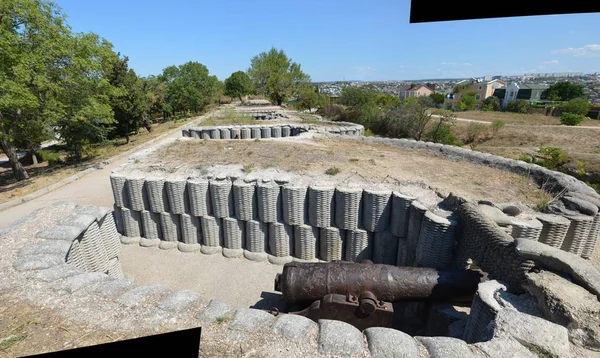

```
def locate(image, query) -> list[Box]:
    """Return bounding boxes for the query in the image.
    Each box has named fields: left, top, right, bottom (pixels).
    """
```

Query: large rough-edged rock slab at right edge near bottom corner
left=525, top=271, right=600, bottom=351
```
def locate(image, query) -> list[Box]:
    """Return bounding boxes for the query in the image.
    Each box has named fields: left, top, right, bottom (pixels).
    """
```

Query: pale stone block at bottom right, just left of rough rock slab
left=492, top=309, right=571, bottom=357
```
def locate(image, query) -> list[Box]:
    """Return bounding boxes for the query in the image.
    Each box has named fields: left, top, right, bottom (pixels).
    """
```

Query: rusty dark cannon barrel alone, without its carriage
left=275, top=261, right=482, bottom=304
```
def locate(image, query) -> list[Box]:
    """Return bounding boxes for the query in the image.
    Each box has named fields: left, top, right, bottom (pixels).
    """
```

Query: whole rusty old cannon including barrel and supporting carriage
left=275, top=261, right=481, bottom=329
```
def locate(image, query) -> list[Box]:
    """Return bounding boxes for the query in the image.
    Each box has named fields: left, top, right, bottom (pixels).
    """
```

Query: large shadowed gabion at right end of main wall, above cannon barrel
left=415, top=211, right=457, bottom=268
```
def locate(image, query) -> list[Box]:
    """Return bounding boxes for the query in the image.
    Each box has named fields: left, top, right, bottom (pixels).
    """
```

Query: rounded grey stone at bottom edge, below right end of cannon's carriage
left=363, top=327, right=420, bottom=358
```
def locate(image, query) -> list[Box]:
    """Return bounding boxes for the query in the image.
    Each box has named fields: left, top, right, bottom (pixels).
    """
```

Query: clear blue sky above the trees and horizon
left=55, top=0, right=600, bottom=81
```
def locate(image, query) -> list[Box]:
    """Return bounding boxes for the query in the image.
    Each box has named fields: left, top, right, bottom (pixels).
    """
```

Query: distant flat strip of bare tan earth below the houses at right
left=456, top=111, right=600, bottom=127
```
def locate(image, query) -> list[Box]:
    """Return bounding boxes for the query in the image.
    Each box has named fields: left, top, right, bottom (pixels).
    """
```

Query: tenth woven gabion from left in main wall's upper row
left=308, top=183, right=335, bottom=227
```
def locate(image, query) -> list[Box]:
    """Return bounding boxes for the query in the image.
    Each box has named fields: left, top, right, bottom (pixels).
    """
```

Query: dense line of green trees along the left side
left=0, top=0, right=222, bottom=180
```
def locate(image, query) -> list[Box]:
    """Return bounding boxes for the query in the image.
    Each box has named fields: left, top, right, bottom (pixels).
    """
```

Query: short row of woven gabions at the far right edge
left=510, top=214, right=600, bottom=259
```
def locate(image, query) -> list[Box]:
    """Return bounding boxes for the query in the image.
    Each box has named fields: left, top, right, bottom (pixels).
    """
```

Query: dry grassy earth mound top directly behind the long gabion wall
left=142, top=139, right=543, bottom=203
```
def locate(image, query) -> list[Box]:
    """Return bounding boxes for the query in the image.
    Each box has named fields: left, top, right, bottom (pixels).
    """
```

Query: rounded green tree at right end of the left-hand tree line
left=159, top=61, right=219, bottom=113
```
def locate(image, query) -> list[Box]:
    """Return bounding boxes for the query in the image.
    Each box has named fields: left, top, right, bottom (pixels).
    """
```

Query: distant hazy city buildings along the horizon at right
left=313, top=72, right=600, bottom=104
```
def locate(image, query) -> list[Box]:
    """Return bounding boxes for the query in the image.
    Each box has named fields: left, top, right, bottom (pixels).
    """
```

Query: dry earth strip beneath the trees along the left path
left=0, top=118, right=202, bottom=203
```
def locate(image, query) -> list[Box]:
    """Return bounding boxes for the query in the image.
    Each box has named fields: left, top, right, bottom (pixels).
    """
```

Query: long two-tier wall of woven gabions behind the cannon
left=111, top=174, right=456, bottom=268
